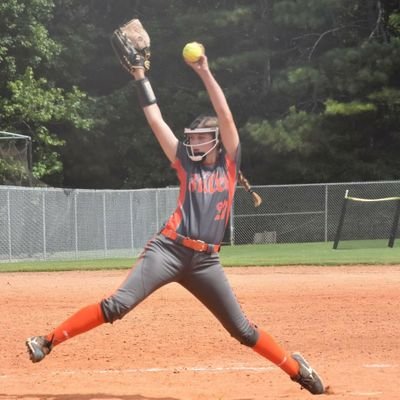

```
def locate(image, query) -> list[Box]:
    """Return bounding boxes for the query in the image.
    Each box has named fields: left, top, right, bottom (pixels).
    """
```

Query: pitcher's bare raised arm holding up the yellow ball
left=187, top=55, right=239, bottom=159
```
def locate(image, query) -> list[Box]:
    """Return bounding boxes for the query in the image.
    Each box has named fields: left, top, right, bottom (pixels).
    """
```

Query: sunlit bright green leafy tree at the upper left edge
left=0, top=0, right=91, bottom=183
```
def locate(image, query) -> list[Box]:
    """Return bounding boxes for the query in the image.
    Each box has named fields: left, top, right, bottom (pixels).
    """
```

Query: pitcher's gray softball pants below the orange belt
left=101, top=234, right=258, bottom=347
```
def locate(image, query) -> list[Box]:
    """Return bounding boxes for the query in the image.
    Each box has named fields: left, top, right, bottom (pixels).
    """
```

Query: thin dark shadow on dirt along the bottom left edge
left=0, top=393, right=179, bottom=400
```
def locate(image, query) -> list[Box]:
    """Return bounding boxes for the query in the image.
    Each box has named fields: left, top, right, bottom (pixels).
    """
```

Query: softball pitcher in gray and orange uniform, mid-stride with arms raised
left=26, top=20, right=325, bottom=394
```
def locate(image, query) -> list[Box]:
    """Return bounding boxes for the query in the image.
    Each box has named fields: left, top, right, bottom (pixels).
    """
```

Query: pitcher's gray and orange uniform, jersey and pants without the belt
left=101, top=143, right=258, bottom=347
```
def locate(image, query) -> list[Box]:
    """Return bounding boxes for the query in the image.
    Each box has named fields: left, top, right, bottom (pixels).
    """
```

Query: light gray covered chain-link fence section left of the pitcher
left=0, top=186, right=178, bottom=261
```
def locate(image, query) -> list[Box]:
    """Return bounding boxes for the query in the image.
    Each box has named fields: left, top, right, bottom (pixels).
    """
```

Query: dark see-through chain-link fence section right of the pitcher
left=232, top=181, right=400, bottom=244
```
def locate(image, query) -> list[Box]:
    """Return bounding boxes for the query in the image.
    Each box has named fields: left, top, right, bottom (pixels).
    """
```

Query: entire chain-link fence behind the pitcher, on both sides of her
left=0, top=181, right=400, bottom=261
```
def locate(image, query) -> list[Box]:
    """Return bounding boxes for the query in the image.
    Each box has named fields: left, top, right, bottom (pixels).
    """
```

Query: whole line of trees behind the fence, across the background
left=0, top=0, right=400, bottom=189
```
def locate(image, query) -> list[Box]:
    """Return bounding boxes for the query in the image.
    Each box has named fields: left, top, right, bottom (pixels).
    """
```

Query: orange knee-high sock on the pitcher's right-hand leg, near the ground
left=253, top=329, right=299, bottom=376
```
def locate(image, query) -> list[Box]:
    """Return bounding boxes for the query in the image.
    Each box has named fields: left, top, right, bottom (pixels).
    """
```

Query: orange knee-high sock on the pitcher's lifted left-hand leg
left=46, top=304, right=105, bottom=346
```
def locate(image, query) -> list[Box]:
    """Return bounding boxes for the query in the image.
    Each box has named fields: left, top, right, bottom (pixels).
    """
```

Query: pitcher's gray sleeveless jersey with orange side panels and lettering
left=165, top=143, right=240, bottom=244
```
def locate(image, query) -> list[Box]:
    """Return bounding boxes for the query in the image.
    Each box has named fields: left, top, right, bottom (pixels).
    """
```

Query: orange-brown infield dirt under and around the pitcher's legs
left=0, top=265, right=400, bottom=400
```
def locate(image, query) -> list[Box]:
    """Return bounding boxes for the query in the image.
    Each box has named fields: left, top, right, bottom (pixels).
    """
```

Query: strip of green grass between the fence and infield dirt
left=0, top=240, right=400, bottom=272
